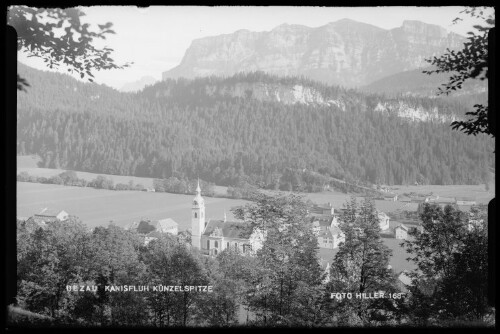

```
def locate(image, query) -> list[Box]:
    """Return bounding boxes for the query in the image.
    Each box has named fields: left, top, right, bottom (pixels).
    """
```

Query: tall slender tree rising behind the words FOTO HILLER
left=328, top=198, right=399, bottom=325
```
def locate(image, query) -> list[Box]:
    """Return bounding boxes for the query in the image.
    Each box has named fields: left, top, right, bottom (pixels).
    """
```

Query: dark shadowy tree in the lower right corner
left=403, top=204, right=488, bottom=322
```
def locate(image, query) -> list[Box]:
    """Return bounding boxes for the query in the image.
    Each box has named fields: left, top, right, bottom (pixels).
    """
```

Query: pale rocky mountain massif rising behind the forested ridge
left=163, top=19, right=465, bottom=87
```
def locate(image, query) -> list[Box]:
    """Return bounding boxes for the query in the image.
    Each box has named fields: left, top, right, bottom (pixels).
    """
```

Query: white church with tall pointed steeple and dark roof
left=191, top=182, right=264, bottom=256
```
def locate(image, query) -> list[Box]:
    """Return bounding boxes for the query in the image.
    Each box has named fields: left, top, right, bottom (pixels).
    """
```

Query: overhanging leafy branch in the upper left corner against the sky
left=7, top=6, right=130, bottom=90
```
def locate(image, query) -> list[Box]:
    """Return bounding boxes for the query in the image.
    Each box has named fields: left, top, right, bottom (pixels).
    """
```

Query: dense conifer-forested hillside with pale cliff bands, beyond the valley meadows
left=18, top=62, right=494, bottom=191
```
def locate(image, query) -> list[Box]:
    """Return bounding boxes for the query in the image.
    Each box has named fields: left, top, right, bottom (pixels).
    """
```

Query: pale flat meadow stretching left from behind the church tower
left=17, top=182, right=247, bottom=231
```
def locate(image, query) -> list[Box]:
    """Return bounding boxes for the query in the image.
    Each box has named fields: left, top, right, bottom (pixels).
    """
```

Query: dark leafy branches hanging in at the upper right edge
left=424, top=7, right=495, bottom=137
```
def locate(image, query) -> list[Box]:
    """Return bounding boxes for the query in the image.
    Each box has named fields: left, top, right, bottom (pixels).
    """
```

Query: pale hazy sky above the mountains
left=19, top=6, right=496, bottom=88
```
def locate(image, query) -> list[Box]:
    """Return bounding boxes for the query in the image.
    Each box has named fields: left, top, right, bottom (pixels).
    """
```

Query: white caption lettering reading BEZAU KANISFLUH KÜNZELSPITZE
left=66, top=285, right=213, bottom=292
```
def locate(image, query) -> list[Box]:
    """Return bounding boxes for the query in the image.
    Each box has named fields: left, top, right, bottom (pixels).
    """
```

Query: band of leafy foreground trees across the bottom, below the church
left=13, top=195, right=491, bottom=327
